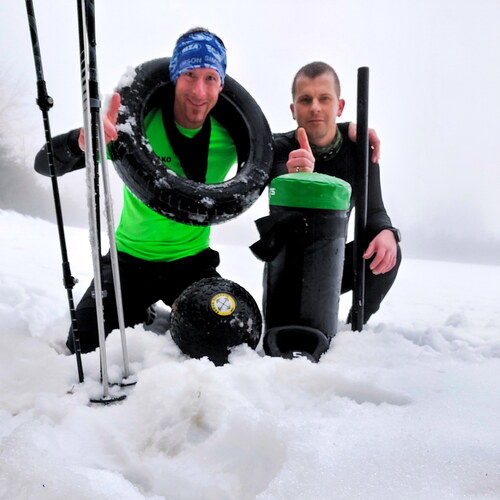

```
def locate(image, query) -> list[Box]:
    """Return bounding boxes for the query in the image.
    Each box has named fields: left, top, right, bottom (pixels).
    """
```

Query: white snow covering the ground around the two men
left=0, top=211, right=500, bottom=500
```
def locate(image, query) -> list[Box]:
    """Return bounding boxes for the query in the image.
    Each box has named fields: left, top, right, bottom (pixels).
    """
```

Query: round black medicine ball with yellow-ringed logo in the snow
left=170, top=278, right=262, bottom=365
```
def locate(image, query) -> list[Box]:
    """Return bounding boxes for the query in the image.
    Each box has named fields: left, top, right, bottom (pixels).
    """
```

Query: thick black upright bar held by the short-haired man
left=351, top=67, right=369, bottom=332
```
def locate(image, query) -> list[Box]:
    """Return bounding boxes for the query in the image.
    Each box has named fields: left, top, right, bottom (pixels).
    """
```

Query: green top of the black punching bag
left=269, top=172, right=351, bottom=210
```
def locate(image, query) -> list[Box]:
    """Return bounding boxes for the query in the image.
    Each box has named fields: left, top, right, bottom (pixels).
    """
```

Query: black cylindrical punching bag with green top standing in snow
left=251, top=173, right=351, bottom=362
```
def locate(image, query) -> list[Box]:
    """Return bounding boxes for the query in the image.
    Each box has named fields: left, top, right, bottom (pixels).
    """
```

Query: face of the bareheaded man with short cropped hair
left=290, top=72, right=345, bottom=146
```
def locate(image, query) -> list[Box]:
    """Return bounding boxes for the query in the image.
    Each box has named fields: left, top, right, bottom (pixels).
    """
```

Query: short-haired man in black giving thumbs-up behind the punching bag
left=271, top=62, right=401, bottom=323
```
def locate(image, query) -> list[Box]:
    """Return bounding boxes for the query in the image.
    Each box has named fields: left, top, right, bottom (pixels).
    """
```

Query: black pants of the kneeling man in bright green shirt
left=66, top=248, right=220, bottom=353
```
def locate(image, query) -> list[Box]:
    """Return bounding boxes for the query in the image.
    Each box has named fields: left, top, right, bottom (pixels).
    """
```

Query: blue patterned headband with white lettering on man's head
left=170, top=32, right=226, bottom=85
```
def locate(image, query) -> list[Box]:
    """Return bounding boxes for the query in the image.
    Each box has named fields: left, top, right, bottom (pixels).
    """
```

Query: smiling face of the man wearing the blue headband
left=174, top=68, right=222, bottom=128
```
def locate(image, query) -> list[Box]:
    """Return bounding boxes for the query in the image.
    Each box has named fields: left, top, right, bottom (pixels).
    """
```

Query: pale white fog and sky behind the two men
left=0, top=0, right=500, bottom=264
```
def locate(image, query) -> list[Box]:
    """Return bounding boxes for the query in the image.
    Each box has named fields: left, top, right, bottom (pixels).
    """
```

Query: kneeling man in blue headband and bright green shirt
left=35, top=28, right=237, bottom=352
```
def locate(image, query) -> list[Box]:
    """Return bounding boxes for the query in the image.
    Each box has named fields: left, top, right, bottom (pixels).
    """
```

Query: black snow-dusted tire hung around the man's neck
left=110, top=58, right=273, bottom=226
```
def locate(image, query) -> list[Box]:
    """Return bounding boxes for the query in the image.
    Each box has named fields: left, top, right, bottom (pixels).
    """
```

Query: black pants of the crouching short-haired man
left=341, top=242, right=401, bottom=323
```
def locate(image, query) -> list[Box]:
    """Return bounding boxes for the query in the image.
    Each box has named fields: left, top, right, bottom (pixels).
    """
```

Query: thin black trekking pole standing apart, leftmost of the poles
left=26, top=0, right=84, bottom=382
